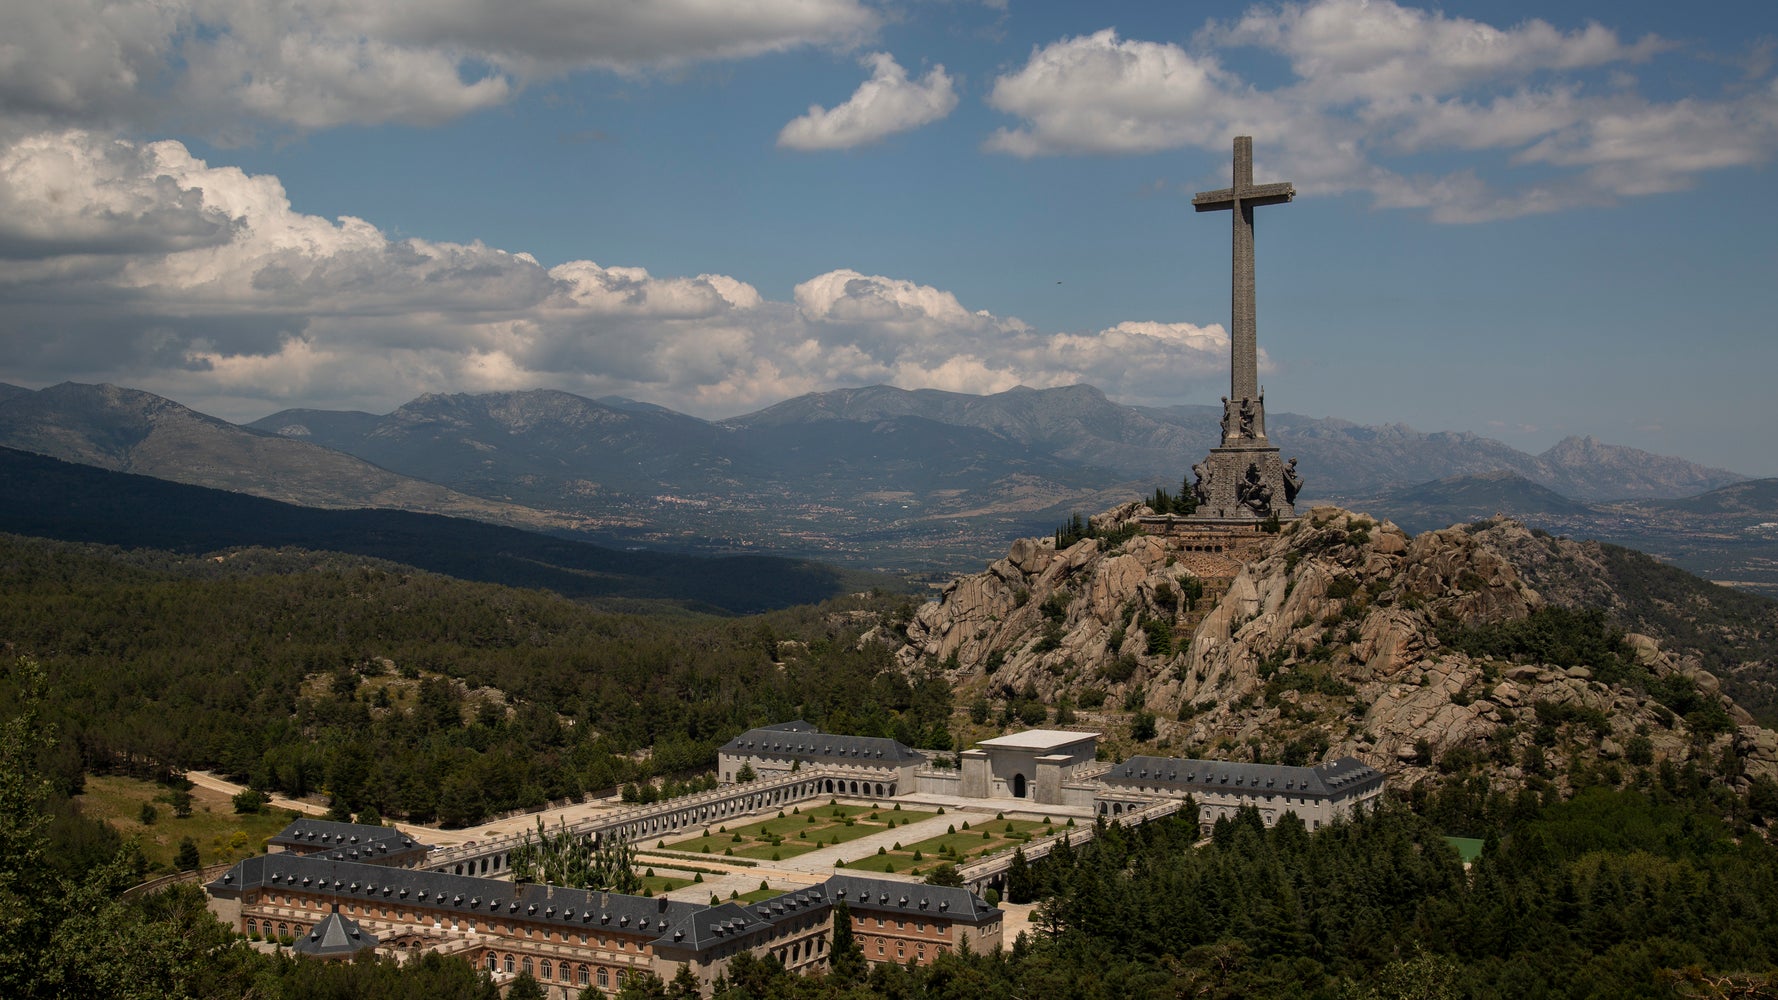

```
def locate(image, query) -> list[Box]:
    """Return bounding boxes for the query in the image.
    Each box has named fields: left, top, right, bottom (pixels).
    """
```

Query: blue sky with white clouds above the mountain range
left=0, top=0, right=1778, bottom=475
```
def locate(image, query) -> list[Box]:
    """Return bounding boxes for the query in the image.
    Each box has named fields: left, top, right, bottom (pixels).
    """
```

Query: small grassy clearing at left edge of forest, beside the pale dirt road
left=78, top=774, right=297, bottom=868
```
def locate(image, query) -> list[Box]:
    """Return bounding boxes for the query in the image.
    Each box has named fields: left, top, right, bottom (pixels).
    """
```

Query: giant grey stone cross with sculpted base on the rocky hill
left=1191, top=135, right=1303, bottom=521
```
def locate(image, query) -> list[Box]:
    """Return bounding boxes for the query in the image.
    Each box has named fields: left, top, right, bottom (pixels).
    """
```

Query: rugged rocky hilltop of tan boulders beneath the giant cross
left=898, top=504, right=1778, bottom=788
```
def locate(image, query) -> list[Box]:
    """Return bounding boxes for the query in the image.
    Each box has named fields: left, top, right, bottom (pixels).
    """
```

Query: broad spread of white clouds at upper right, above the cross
left=985, top=0, right=1778, bottom=222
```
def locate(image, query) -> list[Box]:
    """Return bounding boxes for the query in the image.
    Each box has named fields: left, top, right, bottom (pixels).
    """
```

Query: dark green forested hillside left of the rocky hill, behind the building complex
left=0, top=536, right=951, bottom=824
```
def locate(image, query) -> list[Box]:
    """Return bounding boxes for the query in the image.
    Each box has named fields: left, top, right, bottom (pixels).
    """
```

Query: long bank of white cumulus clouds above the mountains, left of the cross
left=0, top=130, right=1229, bottom=416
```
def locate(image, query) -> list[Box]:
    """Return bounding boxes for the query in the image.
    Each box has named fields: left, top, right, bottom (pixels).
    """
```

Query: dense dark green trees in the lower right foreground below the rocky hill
left=643, top=788, right=1778, bottom=1000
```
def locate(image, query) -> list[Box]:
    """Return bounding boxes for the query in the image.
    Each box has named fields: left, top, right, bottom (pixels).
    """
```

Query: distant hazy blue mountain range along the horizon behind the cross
left=0, top=383, right=1744, bottom=575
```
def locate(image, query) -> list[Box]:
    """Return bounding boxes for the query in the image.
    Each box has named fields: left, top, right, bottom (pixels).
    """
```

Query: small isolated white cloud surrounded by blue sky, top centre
left=779, top=52, right=957, bottom=151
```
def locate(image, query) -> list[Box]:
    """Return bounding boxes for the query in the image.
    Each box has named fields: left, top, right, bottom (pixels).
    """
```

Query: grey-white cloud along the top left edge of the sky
left=0, top=0, right=878, bottom=128
